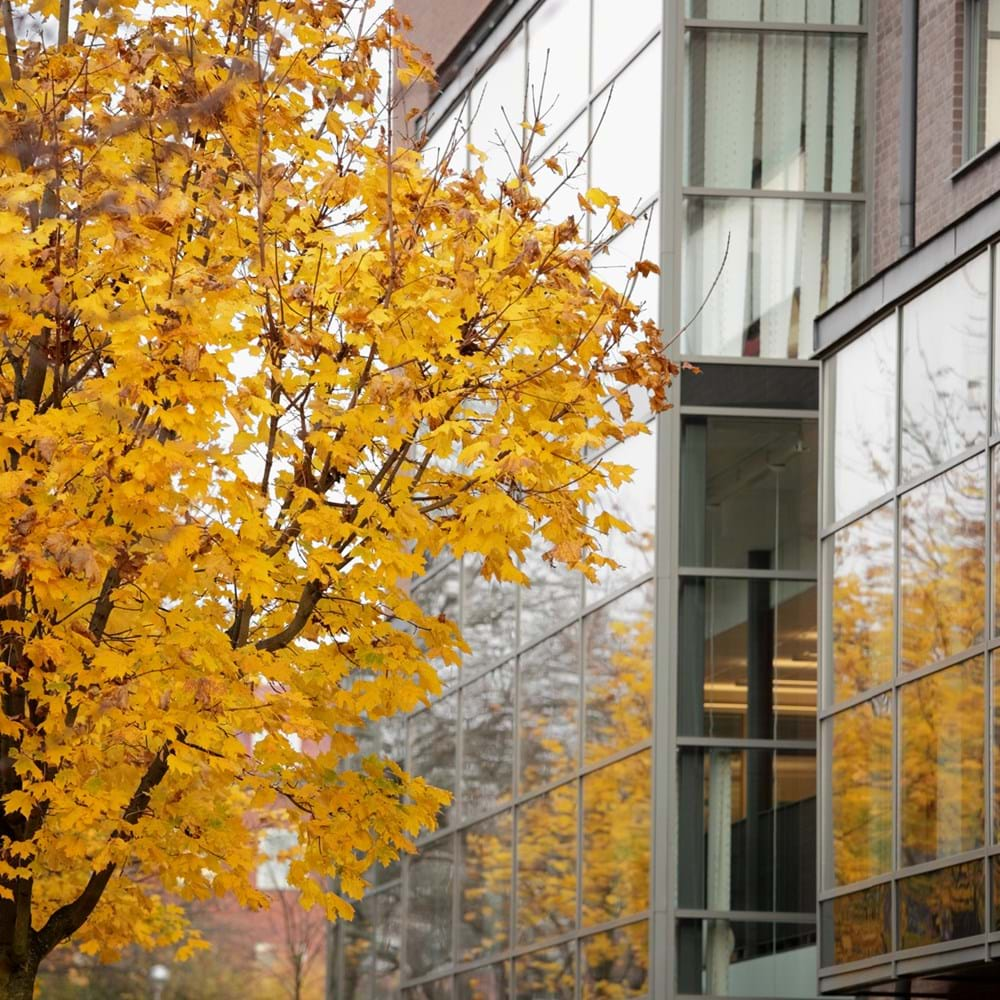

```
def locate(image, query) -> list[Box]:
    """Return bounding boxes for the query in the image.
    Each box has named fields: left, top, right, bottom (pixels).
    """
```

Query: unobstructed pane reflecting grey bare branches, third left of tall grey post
left=462, top=660, right=514, bottom=817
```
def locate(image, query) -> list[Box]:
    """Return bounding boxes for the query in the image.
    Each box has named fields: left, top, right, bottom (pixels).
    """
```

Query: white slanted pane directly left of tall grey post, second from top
left=590, top=40, right=660, bottom=211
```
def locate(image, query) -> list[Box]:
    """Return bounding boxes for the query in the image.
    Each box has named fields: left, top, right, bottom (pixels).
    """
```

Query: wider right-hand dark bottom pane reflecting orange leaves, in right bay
left=896, top=861, right=986, bottom=948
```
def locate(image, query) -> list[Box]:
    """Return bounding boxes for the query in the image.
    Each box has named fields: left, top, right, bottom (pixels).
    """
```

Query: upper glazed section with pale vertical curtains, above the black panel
left=681, top=0, right=866, bottom=358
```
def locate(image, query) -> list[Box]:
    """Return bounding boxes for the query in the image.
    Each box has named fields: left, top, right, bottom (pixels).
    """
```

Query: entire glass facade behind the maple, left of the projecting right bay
left=333, top=0, right=864, bottom=1000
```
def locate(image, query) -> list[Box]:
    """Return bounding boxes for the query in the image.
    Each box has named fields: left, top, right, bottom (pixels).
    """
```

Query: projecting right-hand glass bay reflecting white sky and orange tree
left=820, top=246, right=1000, bottom=978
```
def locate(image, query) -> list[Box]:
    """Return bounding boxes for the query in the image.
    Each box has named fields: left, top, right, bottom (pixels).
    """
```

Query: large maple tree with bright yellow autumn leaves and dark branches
left=0, top=0, right=676, bottom=998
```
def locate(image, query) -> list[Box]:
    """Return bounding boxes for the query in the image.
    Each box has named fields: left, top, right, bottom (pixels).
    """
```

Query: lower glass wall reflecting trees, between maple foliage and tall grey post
left=335, top=434, right=656, bottom=1000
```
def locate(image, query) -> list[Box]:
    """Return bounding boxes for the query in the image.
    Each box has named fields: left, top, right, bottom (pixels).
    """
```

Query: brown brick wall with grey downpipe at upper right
left=871, top=0, right=1000, bottom=273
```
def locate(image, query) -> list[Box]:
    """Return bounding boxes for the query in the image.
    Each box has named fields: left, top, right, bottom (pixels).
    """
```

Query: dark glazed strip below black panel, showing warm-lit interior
left=675, top=394, right=818, bottom=997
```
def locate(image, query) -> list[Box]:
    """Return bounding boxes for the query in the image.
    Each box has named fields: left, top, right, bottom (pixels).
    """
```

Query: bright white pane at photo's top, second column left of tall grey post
left=528, top=0, right=590, bottom=134
